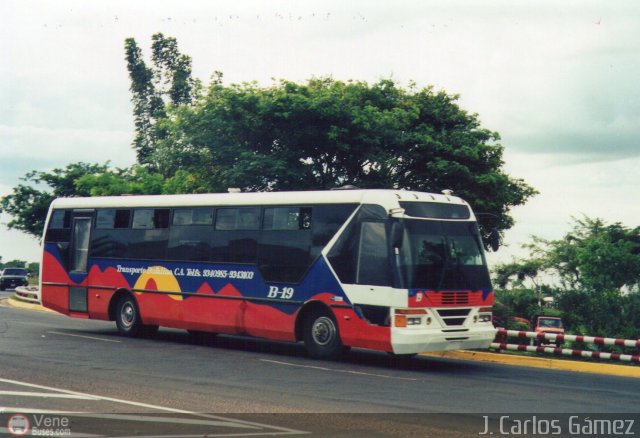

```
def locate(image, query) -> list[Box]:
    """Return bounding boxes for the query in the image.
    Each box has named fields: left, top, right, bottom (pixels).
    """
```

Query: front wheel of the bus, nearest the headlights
left=304, top=310, right=343, bottom=359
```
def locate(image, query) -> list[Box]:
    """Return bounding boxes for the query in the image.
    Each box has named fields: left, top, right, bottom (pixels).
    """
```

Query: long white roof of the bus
left=51, top=190, right=467, bottom=209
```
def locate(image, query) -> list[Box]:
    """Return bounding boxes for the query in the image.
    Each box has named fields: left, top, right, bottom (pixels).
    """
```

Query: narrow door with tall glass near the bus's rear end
left=69, top=210, right=93, bottom=313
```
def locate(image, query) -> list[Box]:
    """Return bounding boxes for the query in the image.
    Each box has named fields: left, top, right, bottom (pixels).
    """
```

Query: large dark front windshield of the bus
left=399, top=219, right=491, bottom=290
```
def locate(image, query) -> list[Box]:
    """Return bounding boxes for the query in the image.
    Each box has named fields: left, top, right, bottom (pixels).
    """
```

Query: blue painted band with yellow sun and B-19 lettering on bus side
left=45, top=244, right=349, bottom=314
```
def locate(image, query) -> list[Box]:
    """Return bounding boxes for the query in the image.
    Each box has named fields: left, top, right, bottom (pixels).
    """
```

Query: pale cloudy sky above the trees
left=0, top=0, right=640, bottom=264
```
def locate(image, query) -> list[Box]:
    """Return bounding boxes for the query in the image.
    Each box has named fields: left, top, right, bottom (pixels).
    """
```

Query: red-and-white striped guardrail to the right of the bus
left=490, top=329, right=640, bottom=363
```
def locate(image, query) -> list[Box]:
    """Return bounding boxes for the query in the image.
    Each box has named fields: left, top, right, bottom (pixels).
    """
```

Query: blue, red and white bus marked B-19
left=40, top=190, right=495, bottom=358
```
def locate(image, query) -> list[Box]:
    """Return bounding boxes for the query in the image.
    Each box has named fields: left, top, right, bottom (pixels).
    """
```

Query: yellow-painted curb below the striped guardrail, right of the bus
left=422, top=350, right=640, bottom=378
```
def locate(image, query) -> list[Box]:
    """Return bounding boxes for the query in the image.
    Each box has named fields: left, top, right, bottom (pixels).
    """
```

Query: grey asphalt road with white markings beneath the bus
left=0, top=306, right=640, bottom=436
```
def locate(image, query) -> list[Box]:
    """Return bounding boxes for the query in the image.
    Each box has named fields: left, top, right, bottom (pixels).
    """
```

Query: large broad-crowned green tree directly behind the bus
left=152, top=77, right=536, bottom=243
